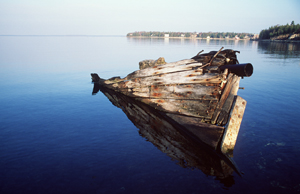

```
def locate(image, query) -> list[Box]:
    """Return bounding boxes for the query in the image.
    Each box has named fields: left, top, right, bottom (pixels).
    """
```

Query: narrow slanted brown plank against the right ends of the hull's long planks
left=211, top=73, right=238, bottom=124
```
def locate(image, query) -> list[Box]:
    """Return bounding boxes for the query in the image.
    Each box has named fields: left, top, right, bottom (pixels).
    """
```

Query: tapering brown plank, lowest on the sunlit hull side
left=139, top=98, right=218, bottom=119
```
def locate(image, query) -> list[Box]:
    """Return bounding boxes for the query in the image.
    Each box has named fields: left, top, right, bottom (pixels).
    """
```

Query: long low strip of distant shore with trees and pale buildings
left=127, top=31, right=254, bottom=39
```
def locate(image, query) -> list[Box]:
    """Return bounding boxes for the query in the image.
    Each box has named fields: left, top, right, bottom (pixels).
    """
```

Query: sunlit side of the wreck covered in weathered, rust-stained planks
left=97, top=59, right=224, bottom=121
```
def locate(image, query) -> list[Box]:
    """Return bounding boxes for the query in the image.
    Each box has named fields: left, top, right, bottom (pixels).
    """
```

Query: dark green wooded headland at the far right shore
left=259, top=21, right=300, bottom=39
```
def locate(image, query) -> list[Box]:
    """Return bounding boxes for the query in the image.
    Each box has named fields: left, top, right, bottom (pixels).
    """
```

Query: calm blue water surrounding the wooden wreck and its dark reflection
left=0, top=36, right=300, bottom=194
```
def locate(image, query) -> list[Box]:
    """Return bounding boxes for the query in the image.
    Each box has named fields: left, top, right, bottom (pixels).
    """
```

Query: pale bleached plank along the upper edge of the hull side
left=125, top=63, right=203, bottom=80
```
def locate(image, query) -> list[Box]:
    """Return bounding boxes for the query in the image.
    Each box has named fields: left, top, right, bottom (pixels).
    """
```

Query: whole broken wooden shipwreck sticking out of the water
left=91, top=47, right=253, bottom=153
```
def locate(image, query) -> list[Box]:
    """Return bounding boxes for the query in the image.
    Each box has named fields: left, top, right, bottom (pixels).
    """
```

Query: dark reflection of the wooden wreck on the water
left=92, top=84, right=241, bottom=187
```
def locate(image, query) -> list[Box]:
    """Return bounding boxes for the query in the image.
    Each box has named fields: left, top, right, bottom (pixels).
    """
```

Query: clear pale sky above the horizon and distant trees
left=0, top=0, right=300, bottom=35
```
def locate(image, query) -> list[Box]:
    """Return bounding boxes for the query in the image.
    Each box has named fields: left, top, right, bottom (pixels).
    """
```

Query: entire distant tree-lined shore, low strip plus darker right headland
left=127, top=21, right=300, bottom=41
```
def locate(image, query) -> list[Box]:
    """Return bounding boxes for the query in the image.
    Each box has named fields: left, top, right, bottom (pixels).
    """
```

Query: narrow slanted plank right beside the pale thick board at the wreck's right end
left=217, top=77, right=240, bottom=126
